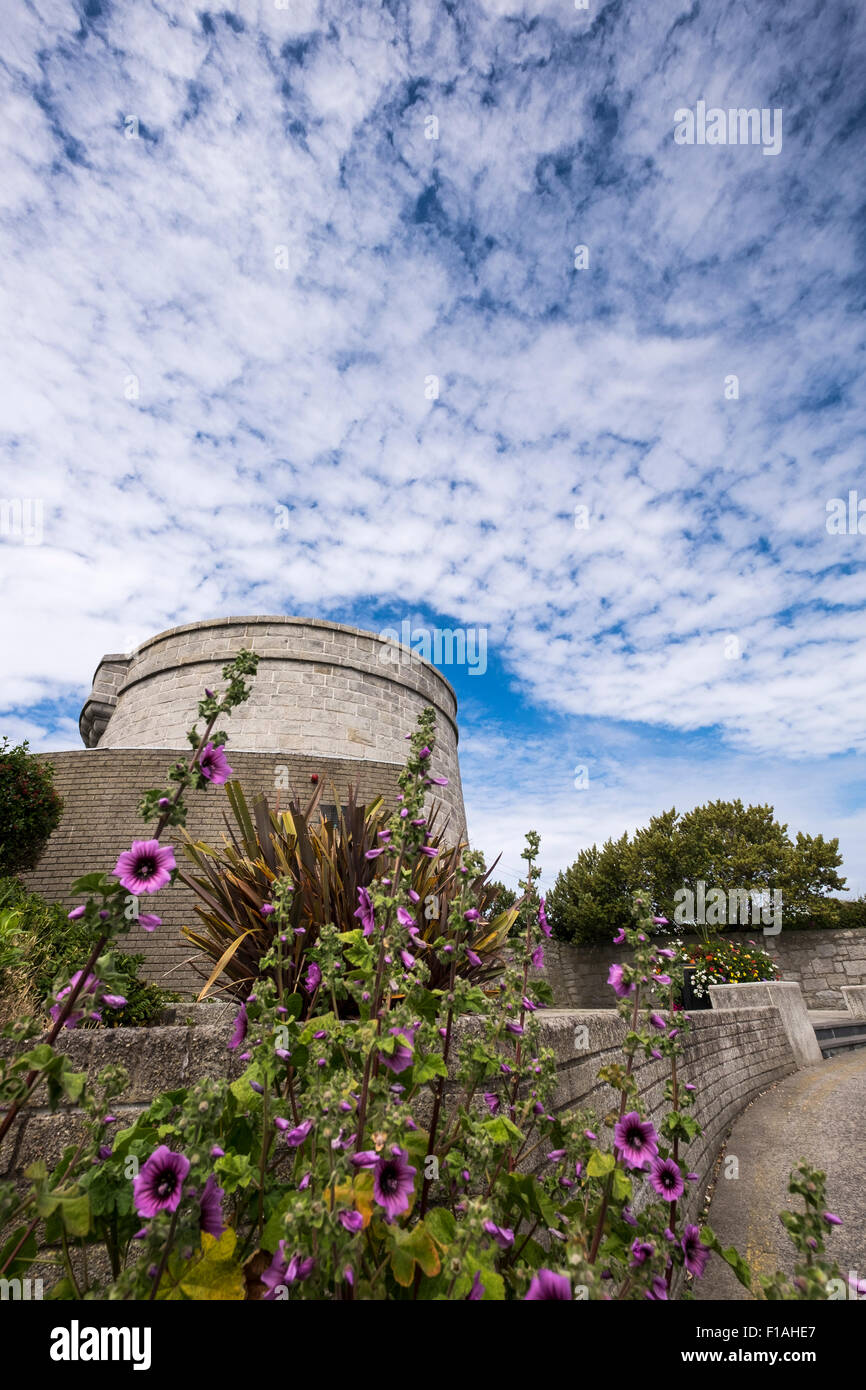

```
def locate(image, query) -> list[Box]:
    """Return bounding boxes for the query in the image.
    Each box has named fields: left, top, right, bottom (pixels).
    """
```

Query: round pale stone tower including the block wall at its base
left=28, top=617, right=466, bottom=994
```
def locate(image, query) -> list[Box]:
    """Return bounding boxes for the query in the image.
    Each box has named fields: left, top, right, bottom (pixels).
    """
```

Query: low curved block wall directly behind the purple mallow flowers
left=0, top=1005, right=795, bottom=1216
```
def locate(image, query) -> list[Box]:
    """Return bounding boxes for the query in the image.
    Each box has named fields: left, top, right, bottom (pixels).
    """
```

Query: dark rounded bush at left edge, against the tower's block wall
left=0, top=738, right=63, bottom=876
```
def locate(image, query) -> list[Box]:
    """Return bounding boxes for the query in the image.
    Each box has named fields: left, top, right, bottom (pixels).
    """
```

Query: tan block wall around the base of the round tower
left=25, top=744, right=463, bottom=997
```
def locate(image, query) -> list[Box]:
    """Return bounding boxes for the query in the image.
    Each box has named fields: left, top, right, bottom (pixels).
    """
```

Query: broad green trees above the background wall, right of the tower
left=548, top=801, right=845, bottom=945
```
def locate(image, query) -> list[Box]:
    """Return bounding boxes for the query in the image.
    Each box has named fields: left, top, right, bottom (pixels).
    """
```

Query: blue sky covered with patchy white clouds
left=0, top=0, right=866, bottom=891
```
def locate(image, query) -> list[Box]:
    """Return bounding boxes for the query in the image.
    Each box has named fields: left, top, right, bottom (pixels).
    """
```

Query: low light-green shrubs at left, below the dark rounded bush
left=0, top=878, right=178, bottom=1027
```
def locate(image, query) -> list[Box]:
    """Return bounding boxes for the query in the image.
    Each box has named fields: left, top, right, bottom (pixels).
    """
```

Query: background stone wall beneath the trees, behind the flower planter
left=545, top=929, right=866, bottom=1009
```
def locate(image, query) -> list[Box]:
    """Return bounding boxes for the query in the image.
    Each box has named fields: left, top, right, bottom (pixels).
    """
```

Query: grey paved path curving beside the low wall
left=695, top=1048, right=866, bottom=1300
